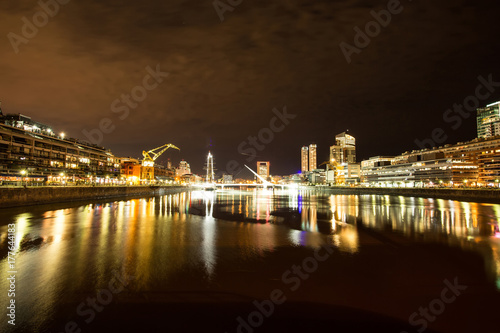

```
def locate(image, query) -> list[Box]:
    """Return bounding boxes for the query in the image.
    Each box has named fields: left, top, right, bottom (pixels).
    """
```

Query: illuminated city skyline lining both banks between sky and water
left=0, top=102, right=500, bottom=186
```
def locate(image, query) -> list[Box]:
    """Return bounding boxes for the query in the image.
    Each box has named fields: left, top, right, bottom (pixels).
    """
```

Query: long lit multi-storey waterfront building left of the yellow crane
left=0, top=113, right=121, bottom=183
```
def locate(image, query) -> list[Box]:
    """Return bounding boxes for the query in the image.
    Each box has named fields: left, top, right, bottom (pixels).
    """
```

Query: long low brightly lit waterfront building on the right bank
left=361, top=137, right=500, bottom=187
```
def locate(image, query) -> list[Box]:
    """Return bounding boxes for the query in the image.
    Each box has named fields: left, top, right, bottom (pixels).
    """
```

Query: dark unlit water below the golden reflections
left=41, top=228, right=500, bottom=333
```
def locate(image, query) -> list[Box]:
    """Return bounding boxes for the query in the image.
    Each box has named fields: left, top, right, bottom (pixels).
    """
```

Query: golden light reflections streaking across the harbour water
left=0, top=190, right=500, bottom=332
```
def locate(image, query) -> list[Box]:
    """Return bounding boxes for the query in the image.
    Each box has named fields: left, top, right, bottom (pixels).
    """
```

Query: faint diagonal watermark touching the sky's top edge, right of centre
left=339, top=0, right=412, bottom=64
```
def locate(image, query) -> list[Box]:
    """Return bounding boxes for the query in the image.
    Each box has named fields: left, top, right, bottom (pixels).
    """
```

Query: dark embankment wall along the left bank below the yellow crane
left=0, top=186, right=189, bottom=208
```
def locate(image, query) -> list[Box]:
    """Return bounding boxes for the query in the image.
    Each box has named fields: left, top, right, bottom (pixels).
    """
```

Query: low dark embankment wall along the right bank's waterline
left=311, top=186, right=500, bottom=203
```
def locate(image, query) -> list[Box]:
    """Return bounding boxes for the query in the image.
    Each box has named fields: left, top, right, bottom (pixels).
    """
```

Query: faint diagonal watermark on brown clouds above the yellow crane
left=82, top=64, right=169, bottom=145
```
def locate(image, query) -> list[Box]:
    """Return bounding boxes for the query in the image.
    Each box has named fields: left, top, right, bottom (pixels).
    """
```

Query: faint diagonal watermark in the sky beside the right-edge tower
left=414, top=74, right=500, bottom=149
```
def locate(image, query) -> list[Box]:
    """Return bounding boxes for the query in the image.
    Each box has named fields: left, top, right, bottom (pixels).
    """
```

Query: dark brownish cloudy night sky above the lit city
left=0, top=0, right=500, bottom=177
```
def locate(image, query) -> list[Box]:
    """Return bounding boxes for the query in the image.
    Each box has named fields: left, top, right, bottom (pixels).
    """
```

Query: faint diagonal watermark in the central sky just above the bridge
left=226, top=105, right=297, bottom=174
